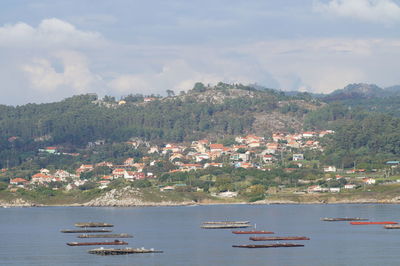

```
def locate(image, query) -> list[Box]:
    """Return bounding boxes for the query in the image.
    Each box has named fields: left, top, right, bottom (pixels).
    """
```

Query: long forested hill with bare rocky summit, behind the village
left=0, top=83, right=321, bottom=149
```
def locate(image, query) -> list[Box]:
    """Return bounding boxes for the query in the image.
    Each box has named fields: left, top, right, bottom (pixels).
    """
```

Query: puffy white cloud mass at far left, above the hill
left=0, top=18, right=106, bottom=102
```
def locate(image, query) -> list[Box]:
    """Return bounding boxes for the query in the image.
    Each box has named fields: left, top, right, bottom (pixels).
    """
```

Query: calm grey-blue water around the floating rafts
left=0, top=204, right=400, bottom=266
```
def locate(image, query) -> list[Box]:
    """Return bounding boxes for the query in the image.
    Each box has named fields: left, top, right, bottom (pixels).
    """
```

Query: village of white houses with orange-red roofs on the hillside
left=2, top=130, right=399, bottom=200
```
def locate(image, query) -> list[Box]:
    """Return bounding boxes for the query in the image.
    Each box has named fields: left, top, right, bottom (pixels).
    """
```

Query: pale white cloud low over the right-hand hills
left=240, top=38, right=400, bottom=92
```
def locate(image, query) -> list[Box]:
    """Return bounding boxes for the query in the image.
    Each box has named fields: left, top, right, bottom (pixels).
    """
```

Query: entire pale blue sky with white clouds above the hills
left=0, top=0, right=400, bottom=105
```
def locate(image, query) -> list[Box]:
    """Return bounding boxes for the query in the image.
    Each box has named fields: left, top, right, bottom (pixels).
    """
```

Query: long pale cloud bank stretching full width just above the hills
left=0, top=17, right=400, bottom=104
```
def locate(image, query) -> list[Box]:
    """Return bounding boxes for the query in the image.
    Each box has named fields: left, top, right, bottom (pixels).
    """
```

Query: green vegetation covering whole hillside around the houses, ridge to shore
left=0, top=83, right=400, bottom=204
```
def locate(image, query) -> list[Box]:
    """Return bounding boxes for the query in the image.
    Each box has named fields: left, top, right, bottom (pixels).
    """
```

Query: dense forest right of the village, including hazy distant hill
left=304, top=84, right=400, bottom=168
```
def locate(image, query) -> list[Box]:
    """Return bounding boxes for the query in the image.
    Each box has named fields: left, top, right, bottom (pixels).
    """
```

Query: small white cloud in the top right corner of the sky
left=314, top=0, right=400, bottom=24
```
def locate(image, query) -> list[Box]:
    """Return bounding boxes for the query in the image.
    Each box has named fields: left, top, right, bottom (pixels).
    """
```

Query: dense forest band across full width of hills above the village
left=0, top=83, right=400, bottom=167
